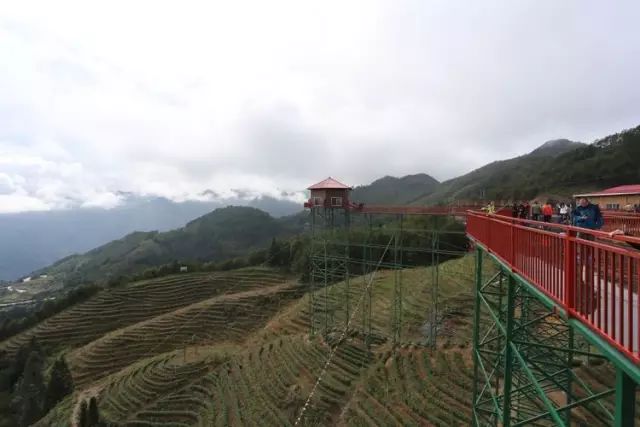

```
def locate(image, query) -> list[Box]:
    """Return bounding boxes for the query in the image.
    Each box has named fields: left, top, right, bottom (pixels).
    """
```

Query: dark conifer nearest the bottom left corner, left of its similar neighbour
left=13, top=351, right=45, bottom=426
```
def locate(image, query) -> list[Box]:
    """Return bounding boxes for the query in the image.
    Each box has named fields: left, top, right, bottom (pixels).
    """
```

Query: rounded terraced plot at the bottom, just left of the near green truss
left=343, top=349, right=473, bottom=426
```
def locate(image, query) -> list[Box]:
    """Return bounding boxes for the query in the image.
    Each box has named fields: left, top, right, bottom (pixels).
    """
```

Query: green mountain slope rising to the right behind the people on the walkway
left=416, top=126, right=640, bottom=204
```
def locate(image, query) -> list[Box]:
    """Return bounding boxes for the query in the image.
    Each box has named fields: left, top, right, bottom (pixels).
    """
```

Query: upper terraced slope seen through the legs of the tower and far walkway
left=267, top=257, right=480, bottom=348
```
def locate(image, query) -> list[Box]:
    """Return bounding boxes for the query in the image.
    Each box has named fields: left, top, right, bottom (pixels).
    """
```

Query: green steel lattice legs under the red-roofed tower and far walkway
left=309, top=207, right=466, bottom=348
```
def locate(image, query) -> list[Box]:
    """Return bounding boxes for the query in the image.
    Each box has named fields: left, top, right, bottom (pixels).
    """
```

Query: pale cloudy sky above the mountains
left=0, top=0, right=640, bottom=213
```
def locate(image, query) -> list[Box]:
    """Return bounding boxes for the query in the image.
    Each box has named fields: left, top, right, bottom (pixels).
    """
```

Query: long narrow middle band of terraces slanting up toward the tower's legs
left=69, top=283, right=301, bottom=386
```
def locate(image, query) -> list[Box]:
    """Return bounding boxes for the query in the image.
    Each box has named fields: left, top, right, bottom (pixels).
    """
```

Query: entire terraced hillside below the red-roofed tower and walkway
left=7, top=257, right=636, bottom=426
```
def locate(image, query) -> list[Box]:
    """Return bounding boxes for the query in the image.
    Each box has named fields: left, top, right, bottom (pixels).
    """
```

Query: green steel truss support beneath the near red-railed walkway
left=473, top=247, right=637, bottom=427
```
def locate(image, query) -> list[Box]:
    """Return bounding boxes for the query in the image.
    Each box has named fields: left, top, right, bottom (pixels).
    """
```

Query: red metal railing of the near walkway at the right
left=467, top=212, right=640, bottom=364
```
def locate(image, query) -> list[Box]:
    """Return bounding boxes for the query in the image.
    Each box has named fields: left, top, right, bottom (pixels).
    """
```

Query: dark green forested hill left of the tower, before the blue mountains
left=35, top=206, right=302, bottom=284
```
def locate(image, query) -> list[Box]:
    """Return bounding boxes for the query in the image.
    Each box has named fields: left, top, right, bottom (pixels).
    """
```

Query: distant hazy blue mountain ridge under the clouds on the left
left=0, top=193, right=302, bottom=280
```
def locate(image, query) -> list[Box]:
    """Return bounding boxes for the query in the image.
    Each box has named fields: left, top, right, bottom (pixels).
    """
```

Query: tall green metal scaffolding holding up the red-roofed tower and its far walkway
left=309, top=206, right=467, bottom=348
